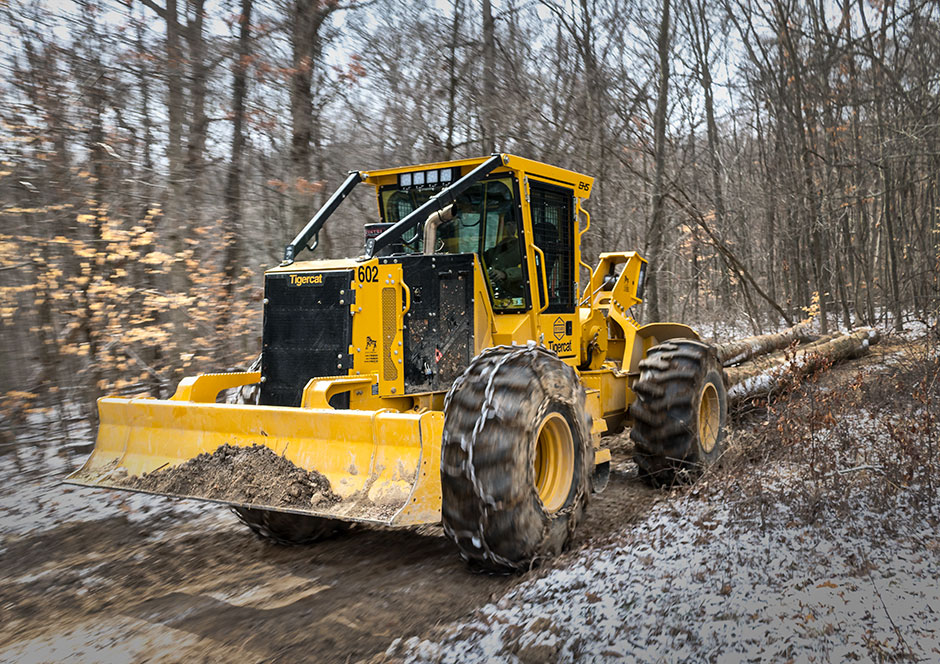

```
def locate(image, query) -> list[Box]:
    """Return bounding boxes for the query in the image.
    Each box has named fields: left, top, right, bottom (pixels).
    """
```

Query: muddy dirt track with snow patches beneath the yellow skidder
left=0, top=436, right=663, bottom=662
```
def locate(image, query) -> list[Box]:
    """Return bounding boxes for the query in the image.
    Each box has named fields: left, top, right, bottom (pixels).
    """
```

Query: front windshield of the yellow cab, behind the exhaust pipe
left=381, top=177, right=526, bottom=310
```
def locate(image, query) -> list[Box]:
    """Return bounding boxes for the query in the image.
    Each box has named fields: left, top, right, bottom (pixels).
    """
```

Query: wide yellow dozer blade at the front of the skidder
left=66, top=397, right=444, bottom=525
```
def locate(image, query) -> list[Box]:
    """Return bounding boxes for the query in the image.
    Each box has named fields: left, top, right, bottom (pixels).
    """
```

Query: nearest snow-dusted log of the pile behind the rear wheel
left=725, top=328, right=879, bottom=401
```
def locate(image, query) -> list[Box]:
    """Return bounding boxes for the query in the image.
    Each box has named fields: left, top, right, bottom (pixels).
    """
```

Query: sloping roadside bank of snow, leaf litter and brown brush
left=387, top=358, right=940, bottom=663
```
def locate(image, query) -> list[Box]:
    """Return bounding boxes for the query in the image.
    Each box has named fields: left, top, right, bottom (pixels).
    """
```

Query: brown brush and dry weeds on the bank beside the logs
left=712, top=340, right=940, bottom=530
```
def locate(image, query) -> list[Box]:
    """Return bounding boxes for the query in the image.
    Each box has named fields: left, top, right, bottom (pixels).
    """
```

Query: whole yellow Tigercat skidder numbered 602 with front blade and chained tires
left=68, top=154, right=726, bottom=570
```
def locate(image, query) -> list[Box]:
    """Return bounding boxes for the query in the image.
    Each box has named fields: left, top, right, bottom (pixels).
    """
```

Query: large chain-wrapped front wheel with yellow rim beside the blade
left=441, top=345, right=594, bottom=572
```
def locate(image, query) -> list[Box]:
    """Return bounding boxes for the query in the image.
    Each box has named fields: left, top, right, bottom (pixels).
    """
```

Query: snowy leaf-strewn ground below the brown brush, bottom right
left=389, top=482, right=940, bottom=662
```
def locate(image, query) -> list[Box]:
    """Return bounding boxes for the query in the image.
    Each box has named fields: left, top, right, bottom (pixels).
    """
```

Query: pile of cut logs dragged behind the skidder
left=717, top=324, right=879, bottom=402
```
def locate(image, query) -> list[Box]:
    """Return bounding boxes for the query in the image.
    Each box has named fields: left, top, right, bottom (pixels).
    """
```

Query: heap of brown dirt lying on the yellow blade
left=115, top=445, right=340, bottom=508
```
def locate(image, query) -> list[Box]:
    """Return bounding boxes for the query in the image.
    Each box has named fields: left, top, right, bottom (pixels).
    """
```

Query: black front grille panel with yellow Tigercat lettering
left=260, top=270, right=355, bottom=408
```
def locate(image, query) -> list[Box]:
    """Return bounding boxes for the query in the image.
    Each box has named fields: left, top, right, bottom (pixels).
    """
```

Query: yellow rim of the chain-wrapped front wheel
left=535, top=413, right=574, bottom=512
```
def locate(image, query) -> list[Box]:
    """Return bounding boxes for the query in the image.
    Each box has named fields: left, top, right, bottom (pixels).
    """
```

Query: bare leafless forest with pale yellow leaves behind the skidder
left=0, top=0, right=940, bottom=430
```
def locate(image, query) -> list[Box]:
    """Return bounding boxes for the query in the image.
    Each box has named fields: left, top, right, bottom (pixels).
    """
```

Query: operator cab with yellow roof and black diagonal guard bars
left=282, top=154, right=593, bottom=322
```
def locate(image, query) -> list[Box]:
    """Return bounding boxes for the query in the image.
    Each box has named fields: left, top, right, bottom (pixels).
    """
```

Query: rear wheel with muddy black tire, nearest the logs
left=630, top=339, right=728, bottom=485
